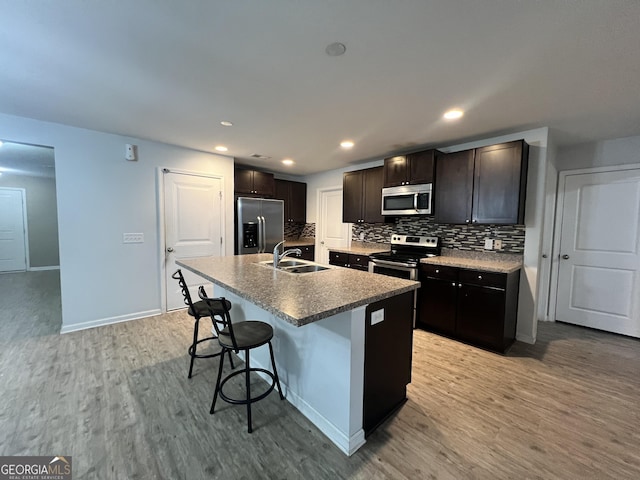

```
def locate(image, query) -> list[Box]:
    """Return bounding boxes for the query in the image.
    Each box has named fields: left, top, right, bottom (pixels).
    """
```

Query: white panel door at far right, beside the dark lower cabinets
left=556, top=169, right=640, bottom=337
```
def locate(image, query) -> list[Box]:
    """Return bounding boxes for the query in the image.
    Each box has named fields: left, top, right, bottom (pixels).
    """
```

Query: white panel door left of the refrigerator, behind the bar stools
left=163, top=170, right=223, bottom=310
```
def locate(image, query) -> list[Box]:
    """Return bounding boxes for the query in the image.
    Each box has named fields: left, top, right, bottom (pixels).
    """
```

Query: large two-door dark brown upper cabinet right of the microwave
left=435, top=140, right=529, bottom=225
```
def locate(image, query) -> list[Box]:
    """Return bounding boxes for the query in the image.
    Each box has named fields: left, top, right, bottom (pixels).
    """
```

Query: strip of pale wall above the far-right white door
left=557, top=136, right=640, bottom=171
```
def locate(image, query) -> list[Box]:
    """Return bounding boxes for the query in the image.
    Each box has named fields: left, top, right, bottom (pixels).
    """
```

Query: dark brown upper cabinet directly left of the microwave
left=342, top=167, right=384, bottom=223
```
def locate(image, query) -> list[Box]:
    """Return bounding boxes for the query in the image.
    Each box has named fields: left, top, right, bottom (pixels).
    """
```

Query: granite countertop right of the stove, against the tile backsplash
left=420, top=249, right=522, bottom=273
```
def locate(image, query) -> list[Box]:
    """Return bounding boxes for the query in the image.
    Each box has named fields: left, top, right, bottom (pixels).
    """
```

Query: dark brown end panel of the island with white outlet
left=362, top=292, right=413, bottom=435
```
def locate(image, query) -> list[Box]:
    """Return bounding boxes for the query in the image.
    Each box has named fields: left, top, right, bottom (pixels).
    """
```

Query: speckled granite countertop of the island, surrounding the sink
left=176, top=253, right=420, bottom=326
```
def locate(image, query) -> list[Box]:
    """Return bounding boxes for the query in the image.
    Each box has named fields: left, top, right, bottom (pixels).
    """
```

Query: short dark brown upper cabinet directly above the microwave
left=383, top=150, right=435, bottom=187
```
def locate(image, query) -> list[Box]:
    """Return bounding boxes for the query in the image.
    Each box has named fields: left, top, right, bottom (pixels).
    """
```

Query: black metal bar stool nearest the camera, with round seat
left=198, top=287, right=284, bottom=433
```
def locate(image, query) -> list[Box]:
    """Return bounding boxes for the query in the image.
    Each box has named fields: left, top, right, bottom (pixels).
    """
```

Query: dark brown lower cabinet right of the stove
left=417, top=264, right=520, bottom=353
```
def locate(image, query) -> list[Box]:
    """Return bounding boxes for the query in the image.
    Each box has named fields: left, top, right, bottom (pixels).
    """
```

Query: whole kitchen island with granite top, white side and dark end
left=177, top=254, right=420, bottom=455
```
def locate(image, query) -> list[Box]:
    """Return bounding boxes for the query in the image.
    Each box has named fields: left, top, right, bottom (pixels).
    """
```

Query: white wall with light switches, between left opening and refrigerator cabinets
left=0, top=114, right=233, bottom=331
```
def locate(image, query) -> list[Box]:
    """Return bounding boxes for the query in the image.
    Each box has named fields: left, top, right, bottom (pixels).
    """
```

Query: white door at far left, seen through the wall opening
left=0, top=188, right=27, bottom=272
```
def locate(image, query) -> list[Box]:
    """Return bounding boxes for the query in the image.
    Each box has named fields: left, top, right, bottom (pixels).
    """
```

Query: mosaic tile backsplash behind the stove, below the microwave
left=351, top=216, right=525, bottom=254
